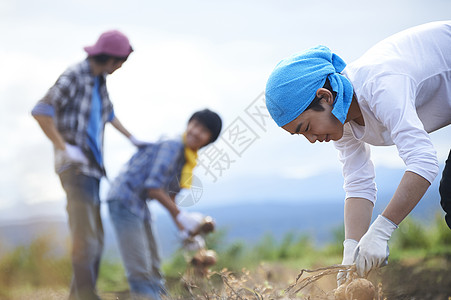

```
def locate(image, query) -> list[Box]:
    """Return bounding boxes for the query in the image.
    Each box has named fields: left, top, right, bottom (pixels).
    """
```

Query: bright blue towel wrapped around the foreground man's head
left=265, top=46, right=353, bottom=127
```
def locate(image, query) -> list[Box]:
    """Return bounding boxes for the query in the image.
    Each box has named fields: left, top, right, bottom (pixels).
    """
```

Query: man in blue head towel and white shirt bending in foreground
left=265, top=21, right=451, bottom=284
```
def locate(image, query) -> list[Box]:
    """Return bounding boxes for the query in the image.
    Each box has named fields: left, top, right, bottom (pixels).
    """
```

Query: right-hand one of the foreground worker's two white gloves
left=354, top=215, right=398, bottom=277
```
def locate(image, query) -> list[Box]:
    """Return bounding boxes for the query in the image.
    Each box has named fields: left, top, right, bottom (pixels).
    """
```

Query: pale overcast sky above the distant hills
left=0, top=0, right=451, bottom=218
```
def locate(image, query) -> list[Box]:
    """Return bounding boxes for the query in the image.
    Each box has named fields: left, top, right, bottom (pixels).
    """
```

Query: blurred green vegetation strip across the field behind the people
left=0, top=215, right=451, bottom=299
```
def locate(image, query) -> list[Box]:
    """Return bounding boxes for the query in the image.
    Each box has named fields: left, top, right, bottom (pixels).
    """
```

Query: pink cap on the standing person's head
left=84, top=30, right=133, bottom=57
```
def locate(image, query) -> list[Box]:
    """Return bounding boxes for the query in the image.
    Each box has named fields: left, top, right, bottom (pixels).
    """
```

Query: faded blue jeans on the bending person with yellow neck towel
left=108, top=200, right=166, bottom=300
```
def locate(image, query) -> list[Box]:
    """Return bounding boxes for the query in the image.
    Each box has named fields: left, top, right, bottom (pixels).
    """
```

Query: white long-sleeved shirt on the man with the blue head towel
left=334, top=21, right=451, bottom=202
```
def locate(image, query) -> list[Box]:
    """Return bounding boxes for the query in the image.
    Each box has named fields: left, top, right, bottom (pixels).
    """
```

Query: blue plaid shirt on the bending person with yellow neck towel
left=107, top=137, right=185, bottom=219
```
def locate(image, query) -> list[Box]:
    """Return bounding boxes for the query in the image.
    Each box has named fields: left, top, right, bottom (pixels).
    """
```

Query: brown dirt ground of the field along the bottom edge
left=4, top=256, right=451, bottom=300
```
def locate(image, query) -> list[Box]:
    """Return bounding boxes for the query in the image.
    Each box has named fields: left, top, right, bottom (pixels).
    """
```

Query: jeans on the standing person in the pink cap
left=60, top=168, right=103, bottom=300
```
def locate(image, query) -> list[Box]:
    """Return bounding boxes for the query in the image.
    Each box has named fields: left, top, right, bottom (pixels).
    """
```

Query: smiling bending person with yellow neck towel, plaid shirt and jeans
left=107, top=109, right=222, bottom=299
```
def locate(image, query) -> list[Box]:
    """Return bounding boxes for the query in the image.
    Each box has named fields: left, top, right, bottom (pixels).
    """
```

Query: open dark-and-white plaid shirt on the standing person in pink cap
left=32, top=59, right=114, bottom=179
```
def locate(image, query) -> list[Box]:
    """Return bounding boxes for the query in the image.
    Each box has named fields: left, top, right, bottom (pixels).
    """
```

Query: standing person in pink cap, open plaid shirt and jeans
left=31, top=30, right=145, bottom=300
